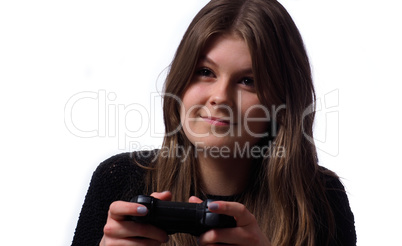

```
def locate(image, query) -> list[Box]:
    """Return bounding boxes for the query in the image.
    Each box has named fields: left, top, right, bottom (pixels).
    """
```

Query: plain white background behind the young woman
left=0, top=0, right=402, bottom=245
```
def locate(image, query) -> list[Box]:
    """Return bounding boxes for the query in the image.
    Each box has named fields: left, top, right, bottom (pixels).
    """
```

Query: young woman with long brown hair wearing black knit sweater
left=73, top=0, right=356, bottom=245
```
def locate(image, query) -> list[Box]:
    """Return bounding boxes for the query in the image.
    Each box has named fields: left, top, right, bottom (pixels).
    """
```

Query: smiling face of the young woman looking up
left=180, top=35, right=269, bottom=154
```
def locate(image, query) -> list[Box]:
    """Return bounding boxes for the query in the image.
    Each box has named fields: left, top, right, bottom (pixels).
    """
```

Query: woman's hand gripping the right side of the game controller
left=189, top=196, right=271, bottom=246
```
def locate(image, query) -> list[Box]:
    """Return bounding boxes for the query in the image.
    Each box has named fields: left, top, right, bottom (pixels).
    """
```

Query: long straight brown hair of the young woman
left=143, top=0, right=335, bottom=245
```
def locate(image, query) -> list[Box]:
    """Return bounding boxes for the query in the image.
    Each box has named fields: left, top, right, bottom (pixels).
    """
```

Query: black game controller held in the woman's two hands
left=130, top=195, right=236, bottom=236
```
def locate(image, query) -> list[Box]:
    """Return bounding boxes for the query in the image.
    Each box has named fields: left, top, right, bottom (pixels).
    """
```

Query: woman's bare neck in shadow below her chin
left=198, top=154, right=252, bottom=196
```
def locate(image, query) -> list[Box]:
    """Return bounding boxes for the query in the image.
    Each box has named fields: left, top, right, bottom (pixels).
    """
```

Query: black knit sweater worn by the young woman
left=72, top=151, right=356, bottom=246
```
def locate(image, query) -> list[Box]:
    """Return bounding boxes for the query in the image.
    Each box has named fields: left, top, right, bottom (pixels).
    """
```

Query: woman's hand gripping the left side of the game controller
left=100, top=192, right=172, bottom=246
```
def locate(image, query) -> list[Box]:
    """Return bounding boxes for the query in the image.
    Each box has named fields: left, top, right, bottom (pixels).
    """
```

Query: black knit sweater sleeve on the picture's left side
left=72, top=153, right=150, bottom=246
